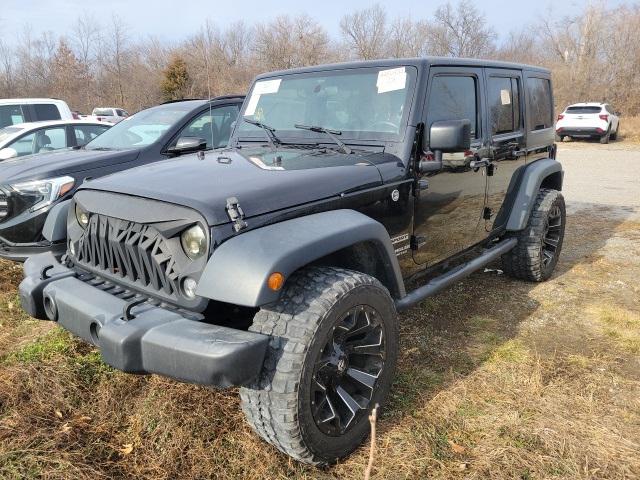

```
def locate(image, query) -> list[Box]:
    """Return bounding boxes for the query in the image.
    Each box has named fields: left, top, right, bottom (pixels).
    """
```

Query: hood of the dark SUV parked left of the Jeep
left=0, top=149, right=140, bottom=184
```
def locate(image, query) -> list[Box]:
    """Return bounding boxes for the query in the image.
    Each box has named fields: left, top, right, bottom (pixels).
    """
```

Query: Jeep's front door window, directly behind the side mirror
left=427, top=75, right=478, bottom=138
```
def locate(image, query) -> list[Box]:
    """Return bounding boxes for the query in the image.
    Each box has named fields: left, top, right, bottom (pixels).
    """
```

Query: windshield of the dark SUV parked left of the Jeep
left=85, top=104, right=193, bottom=150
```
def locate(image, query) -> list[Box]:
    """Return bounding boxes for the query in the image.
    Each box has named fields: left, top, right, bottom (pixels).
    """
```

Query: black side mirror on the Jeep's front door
left=419, top=118, right=471, bottom=173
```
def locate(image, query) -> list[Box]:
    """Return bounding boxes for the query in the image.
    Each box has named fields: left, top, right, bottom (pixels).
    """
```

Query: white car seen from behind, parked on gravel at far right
left=556, top=102, right=620, bottom=143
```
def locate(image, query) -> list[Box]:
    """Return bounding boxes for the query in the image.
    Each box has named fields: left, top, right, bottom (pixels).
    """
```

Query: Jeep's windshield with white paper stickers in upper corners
left=237, top=66, right=417, bottom=142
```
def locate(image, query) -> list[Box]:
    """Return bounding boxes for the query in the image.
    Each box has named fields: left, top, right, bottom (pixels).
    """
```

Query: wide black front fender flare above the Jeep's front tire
left=196, top=210, right=405, bottom=307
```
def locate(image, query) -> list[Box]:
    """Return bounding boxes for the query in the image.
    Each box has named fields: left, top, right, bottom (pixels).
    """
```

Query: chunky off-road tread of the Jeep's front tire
left=240, top=267, right=392, bottom=466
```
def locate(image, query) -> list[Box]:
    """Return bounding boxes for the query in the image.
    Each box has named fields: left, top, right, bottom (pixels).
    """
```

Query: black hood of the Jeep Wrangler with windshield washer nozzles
left=81, top=147, right=398, bottom=226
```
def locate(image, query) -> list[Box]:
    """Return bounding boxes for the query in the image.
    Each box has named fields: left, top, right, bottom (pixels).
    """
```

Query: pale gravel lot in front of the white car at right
left=558, top=142, right=640, bottom=220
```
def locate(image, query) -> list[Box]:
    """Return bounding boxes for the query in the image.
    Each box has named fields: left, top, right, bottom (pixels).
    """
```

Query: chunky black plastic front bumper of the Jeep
left=20, top=253, right=270, bottom=387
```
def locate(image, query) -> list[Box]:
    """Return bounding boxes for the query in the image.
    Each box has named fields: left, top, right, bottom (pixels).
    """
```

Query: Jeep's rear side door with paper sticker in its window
left=483, top=68, right=527, bottom=232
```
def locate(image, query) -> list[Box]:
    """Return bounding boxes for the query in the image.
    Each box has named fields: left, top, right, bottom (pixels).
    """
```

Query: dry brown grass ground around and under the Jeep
left=0, top=207, right=640, bottom=479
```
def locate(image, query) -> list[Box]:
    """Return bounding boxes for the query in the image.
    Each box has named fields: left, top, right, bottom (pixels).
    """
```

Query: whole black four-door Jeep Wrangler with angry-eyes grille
left=20, top=58, right=565, bottom=465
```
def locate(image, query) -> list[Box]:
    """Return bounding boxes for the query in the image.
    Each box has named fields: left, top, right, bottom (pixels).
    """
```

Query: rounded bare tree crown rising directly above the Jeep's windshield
left=340, top=4, right=387, bottom=60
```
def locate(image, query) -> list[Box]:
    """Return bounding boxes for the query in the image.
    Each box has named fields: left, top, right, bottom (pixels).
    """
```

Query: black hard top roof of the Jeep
left=256, top=57, right=551, bottom=78
